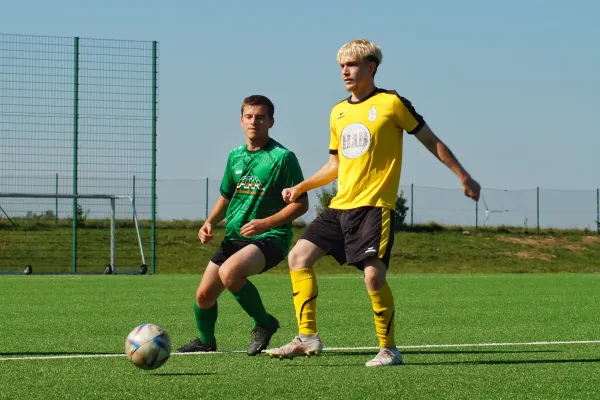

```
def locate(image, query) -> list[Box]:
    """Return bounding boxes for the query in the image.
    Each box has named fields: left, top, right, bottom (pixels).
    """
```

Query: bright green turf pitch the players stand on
left=0, top=274, right=600, bottom=399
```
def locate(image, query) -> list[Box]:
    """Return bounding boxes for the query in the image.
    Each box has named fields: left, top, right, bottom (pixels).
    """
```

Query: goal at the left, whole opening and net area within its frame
left=0, top=193, right=147, bottom=274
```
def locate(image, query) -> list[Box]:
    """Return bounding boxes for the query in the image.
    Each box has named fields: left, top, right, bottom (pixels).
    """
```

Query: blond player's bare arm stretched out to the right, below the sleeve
left=414, top=124, right=481, bottom=201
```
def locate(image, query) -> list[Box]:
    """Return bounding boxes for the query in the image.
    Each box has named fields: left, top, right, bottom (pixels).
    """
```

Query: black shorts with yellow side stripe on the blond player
left=300, top=207, right=395, bottom=270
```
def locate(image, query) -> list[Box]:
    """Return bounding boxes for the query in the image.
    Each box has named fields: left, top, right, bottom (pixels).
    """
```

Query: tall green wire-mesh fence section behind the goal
left=0, top=33, right=160, bottom=274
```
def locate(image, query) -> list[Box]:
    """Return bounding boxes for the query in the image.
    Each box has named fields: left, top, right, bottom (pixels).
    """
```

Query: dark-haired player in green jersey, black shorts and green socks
left=177, top=95, right=308, bottom=356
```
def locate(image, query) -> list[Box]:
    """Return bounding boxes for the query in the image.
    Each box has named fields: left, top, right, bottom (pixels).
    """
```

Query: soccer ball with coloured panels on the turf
left=125, top=324, right=171, bottom=369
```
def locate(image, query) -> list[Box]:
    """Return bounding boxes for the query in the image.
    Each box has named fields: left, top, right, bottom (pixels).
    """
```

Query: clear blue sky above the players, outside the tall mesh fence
left=0, top=0, right=600, bottom=195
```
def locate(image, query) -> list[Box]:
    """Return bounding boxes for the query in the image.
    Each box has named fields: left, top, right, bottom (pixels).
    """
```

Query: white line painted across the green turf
left=0, top=340, right=600, bottom=361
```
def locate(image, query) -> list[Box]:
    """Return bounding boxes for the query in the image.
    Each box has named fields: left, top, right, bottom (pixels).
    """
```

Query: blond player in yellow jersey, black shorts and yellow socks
left=266, top=40, right=480, bottom=367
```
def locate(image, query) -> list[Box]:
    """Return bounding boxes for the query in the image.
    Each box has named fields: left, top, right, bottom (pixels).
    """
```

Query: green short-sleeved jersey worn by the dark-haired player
left=221, top=139, right=306, bottom=256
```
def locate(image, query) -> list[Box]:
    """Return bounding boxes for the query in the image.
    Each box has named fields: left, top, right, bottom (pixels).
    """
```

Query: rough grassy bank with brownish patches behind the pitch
left=0, top=222, right=600, bottom=274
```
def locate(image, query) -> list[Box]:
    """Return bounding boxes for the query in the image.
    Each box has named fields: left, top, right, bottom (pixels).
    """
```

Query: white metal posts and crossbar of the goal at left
left=0, top=193, right=148, bottom=274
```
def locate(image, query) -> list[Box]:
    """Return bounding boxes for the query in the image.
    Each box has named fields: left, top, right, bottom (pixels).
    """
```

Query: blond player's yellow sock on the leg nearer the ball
left=290, top=268, right=319, bottom=336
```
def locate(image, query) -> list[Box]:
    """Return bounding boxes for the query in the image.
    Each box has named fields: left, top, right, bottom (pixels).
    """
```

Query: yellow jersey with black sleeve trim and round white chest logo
left=329, top=89, right=425, bottom=210
